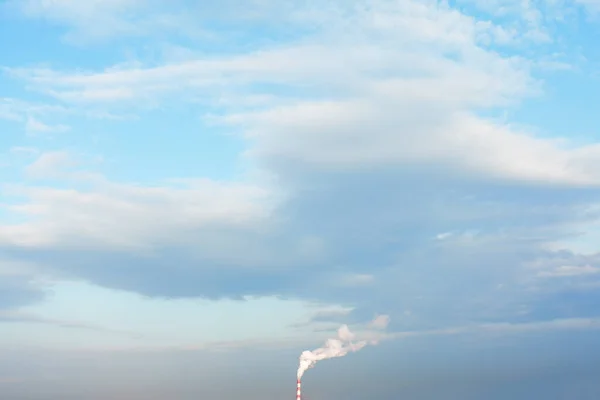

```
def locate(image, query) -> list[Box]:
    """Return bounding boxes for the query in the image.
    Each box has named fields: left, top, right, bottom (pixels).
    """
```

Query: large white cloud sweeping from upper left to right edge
left=12, top=1, right=600, bottom=189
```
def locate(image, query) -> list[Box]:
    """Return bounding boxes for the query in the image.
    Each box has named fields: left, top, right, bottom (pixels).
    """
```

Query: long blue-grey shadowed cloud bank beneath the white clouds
left=5, top=164, right=597, bottom=329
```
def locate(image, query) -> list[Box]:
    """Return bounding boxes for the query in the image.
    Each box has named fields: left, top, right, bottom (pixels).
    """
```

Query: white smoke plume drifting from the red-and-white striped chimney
left=298, top=315, right=390, bottom=380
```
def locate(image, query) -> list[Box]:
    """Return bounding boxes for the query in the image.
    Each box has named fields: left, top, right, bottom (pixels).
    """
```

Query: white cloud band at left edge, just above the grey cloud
left=0, top=176, right=269, bottom=252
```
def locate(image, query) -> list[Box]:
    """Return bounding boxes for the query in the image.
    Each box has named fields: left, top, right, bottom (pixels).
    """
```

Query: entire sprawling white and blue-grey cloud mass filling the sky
left=0, top=1, right=600, bottom=344
